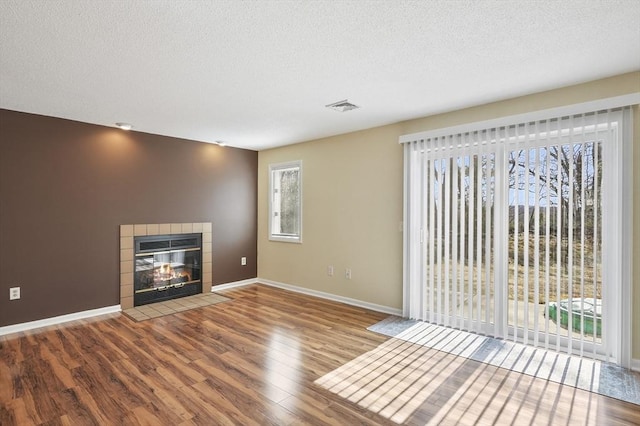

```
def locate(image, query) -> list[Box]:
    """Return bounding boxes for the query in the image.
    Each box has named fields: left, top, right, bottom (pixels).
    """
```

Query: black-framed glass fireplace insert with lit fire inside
left=133, top=234, right=202, bottom=306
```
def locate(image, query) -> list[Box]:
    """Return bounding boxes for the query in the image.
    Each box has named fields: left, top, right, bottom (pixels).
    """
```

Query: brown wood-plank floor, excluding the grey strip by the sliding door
left=0, top=285, right=640, bottom=426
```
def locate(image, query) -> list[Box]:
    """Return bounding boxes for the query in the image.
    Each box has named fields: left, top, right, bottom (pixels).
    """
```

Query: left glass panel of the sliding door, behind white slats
left=424, top=152, right=496, bottom=333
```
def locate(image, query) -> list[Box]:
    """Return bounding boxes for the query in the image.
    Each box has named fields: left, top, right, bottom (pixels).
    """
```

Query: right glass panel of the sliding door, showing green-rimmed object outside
left=506, top=122, right=616, bottom=356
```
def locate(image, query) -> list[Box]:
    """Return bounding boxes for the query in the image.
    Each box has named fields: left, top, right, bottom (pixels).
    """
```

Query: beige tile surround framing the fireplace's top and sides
left=120, top=222, right=213, bottom=310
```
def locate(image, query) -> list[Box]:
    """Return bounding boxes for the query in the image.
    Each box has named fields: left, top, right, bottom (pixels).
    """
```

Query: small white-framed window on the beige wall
left=269, top=161, right=302, bottom=243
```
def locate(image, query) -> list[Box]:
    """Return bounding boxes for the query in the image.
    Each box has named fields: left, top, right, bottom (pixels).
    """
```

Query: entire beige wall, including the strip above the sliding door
left=258, top=72, right=640, bottom=358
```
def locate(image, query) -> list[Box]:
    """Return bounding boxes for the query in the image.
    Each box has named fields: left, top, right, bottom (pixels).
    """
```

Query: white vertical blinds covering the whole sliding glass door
left=403, top=106, right=628, bottom=357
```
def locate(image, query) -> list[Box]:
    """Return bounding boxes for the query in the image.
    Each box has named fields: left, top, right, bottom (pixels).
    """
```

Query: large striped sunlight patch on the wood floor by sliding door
left=315, top=334, right=598, bottom=424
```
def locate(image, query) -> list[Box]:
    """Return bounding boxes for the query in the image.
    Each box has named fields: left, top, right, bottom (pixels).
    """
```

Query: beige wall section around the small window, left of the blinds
left=258, top=126, right=402, bottom=308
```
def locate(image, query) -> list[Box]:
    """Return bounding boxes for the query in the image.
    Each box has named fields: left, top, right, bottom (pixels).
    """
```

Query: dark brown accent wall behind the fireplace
left=0, top=109, right=258, bottom=326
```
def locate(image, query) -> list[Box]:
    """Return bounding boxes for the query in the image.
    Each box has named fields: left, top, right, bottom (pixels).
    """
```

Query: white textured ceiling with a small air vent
left=0, top=0, right=640, bottom=150
